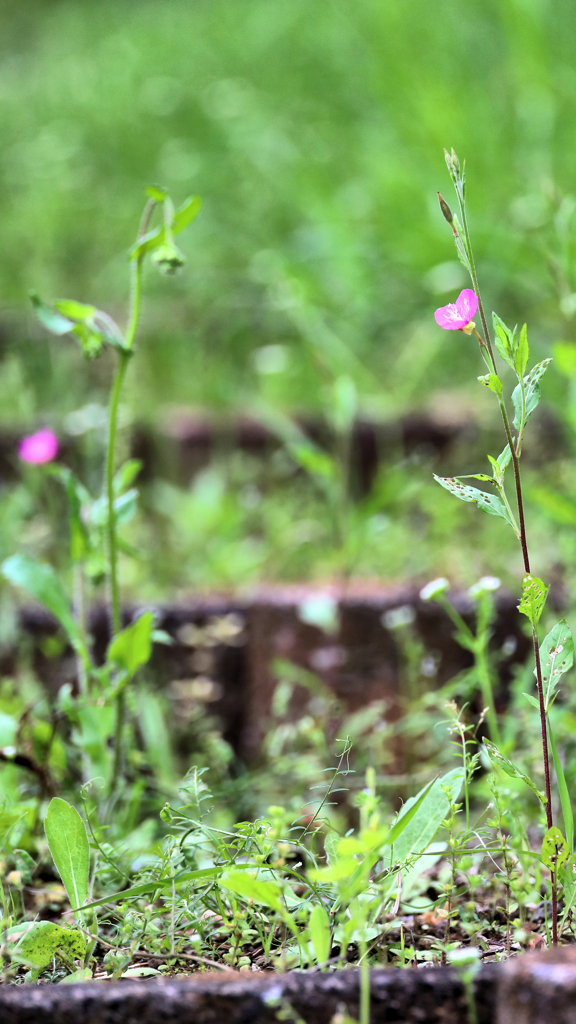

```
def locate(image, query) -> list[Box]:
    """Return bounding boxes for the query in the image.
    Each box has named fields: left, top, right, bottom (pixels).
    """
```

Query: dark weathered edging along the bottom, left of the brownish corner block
left=0, top=966, right=501, bottom=1024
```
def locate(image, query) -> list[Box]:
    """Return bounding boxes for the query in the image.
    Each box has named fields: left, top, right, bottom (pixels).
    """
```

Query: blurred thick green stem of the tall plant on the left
left=106, top=200, right=156, bottom=795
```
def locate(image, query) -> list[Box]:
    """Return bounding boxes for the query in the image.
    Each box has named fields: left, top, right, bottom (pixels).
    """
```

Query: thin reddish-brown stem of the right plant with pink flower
left=456, top=176, right=558, bottom=946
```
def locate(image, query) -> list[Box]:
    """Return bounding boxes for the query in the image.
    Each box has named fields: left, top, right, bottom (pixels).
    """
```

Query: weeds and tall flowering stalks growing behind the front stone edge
left=0, top=153, right=576, bottom=1003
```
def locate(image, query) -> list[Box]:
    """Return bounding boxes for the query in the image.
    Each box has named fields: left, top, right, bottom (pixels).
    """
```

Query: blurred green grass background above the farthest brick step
left=0, top=0, right=576, bottom=423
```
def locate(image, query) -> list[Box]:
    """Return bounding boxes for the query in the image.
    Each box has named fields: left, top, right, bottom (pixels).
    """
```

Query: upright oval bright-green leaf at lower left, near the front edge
left=44, top=797, right=90, bottom=908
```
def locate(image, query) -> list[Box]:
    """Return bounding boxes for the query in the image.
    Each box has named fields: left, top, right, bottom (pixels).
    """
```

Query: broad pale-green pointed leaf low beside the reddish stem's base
left=386, top=768, right=464, bottom=863
